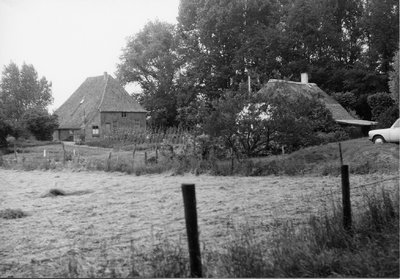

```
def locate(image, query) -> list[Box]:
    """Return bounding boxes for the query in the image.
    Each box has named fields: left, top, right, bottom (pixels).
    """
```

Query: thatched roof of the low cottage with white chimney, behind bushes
left=258, top=79, right=375, bottom=125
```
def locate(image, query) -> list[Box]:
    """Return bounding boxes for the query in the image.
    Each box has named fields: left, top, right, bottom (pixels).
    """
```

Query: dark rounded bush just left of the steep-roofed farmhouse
left=21, top=108, right=58, bottom=140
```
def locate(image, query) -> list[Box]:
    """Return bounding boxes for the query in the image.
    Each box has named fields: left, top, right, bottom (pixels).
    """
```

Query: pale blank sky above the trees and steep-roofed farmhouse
left=0, top=0, right=179, bottom=112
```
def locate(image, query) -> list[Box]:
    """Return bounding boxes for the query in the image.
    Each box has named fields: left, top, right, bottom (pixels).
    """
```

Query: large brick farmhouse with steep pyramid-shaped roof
left=53, top=72, right=147, bottom=141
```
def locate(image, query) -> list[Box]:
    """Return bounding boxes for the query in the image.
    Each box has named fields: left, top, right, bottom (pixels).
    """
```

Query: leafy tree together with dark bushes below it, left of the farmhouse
left=0, top=62, right=58, bottom=143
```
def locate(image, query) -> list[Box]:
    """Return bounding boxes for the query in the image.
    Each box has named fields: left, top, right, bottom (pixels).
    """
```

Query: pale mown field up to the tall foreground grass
left=0, top=169, right=393, bottom=275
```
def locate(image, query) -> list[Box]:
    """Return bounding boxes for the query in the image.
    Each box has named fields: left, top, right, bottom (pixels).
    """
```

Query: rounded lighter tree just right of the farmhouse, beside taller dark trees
left=117, top=21, right=181, bottom=126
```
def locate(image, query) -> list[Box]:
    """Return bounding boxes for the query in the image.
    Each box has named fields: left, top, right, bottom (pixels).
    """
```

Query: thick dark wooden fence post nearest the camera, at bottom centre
left=182, top=184, right=203, bottom=278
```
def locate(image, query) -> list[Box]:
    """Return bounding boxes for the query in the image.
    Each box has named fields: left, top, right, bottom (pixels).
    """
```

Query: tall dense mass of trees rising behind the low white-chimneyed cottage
left=117, top=0, right=399, bottom=129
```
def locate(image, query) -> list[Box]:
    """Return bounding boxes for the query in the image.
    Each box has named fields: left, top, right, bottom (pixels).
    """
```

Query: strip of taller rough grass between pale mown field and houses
left=0, top=138, right=399, bottom=176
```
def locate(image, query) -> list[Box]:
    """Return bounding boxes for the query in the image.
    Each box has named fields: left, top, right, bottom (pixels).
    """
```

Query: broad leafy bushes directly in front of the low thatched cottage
left=202, top=84, right=341, bottom=156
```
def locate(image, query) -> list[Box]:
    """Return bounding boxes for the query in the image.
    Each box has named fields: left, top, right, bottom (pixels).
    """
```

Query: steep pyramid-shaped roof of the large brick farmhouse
left=54, top=73, right=147, bottom=129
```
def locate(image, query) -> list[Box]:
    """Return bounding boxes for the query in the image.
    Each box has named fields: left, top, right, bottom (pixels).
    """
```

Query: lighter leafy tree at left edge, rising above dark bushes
left=0, top=62, right=53, bottom=121
